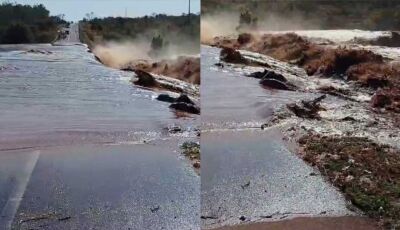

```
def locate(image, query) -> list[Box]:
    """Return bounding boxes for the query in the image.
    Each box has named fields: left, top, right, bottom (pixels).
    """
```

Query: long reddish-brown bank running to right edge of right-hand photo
left=208, top=33, right=400, bottom=112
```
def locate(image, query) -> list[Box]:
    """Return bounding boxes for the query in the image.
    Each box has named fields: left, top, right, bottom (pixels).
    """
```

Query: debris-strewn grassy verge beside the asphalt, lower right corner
left=299, top=135, right=400, bottom=229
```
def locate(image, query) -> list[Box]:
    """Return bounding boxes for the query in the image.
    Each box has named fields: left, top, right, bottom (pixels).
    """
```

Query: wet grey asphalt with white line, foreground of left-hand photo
left=0, top=140, right=200, bottom=229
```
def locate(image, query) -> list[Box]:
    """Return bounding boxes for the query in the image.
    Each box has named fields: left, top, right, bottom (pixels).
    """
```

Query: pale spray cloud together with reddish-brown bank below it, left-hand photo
left=92, top=40, right=200, bottom=84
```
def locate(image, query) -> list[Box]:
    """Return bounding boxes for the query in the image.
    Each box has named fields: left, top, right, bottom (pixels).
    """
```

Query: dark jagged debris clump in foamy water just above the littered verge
left=287, top=94, right=326, bottom=119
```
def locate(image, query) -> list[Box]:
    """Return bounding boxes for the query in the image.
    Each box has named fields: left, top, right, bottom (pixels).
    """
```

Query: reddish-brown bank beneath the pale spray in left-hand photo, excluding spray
left=123, top=56, right=200, bottom=84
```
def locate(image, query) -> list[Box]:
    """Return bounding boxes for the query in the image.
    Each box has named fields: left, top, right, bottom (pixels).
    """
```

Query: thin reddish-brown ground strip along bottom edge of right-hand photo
left=215, top=216, right=380, bottom=230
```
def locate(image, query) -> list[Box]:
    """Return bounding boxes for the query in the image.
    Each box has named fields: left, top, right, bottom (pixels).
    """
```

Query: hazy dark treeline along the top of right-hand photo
left=201, top=0, right=400, bottom=30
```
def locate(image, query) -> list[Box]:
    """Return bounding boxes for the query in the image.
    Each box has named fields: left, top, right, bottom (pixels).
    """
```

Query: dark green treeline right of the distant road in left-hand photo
left=80, top=14, right=200, bottom=46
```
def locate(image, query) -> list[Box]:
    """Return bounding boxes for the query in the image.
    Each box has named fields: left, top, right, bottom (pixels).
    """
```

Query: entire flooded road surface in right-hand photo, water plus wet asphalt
left=201, top=46, right=354, bottom=229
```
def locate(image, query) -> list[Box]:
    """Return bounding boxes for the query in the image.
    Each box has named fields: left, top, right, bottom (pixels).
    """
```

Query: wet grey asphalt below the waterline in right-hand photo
left=201, top=131, right=351, bottom=227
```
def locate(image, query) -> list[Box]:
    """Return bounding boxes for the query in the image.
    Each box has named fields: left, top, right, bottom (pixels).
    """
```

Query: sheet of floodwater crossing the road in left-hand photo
left=0, top=33, right=195, bottom=149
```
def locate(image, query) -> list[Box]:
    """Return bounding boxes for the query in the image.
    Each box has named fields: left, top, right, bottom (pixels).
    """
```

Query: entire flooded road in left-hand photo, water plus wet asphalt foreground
left=0, top=26, right=200, bottom=229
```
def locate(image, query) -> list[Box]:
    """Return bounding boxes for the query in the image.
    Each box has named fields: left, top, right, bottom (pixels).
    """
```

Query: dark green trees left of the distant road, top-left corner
left=0, top=3, right=68, bottom=44
